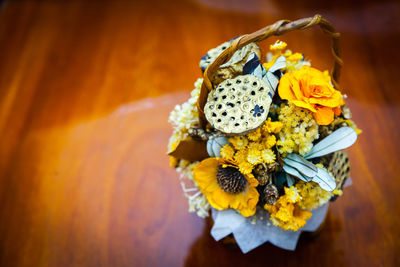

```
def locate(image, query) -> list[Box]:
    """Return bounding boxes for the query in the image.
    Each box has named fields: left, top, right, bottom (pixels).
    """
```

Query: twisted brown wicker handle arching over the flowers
left=197, top=15, right=343, bottom=129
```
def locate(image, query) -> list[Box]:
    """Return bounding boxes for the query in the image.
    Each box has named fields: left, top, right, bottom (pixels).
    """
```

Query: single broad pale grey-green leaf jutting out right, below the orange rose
left=304, top=127, right=357, bottom=159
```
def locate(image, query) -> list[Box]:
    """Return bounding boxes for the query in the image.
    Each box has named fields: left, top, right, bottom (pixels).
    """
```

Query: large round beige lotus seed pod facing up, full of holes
left=204, top=74, right=272, bottom=135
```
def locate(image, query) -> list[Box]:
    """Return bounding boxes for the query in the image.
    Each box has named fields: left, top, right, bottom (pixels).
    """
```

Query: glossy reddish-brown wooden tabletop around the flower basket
left=0, top=0, right=400, bottom=266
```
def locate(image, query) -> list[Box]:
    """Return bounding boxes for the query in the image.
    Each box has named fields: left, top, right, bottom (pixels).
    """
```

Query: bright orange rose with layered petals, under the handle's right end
left=278, top=66, right=344, bottom=125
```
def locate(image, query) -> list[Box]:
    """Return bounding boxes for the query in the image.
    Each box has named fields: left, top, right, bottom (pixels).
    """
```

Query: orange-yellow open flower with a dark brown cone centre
left=193, top=158, right=259, bottom=217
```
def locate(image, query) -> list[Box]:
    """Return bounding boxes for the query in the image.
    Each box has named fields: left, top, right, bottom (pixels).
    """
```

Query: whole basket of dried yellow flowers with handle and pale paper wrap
left=168, top=15, right=361, bottom=253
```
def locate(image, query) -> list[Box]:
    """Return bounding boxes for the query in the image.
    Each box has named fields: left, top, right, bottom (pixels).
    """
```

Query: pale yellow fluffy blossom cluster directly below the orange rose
left=277, top=103, right=319, bottom=155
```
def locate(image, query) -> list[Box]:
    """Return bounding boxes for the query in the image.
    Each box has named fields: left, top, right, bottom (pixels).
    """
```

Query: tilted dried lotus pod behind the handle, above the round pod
left=200, top=41, right=261, bottom=84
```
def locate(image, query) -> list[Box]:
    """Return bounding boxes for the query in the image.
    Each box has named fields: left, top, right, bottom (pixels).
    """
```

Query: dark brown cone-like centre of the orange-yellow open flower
left=217, top=166, right=247, bottom=194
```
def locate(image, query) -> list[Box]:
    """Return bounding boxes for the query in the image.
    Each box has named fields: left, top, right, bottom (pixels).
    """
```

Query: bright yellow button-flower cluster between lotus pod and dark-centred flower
left=221, top=118, right=283, bottom=174
